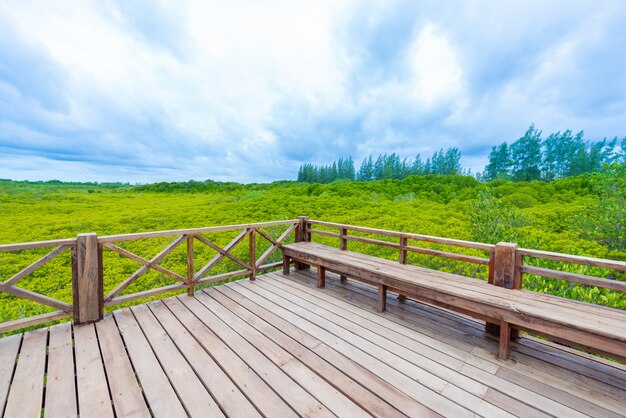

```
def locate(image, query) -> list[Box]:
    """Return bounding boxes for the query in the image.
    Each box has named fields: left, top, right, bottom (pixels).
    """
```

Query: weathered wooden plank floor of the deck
left=0, top=271, right=626, bottom=417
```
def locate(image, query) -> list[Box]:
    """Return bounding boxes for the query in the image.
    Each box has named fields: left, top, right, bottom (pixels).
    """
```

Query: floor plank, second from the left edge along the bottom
left=4, top=329, right=48, bottom=418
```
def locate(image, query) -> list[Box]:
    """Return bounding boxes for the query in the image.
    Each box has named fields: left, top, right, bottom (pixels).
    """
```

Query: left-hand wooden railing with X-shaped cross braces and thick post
left=0, top=219, right=302, bottom=333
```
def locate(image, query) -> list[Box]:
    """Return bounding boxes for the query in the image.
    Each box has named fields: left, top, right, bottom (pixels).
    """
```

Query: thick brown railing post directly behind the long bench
left=485, top=242, right=521, bottom=339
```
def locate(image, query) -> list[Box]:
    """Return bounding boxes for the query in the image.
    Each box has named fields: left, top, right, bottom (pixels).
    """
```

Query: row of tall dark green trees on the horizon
left=298, top=125, right=626, bottom=183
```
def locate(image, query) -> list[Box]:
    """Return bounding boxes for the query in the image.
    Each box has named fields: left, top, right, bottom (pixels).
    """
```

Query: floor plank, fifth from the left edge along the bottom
left=96, top=315, right=150, bottom=417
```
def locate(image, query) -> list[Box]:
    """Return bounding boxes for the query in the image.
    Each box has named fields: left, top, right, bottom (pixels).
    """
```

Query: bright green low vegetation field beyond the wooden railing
left=0, top=168, right=626, bottom=328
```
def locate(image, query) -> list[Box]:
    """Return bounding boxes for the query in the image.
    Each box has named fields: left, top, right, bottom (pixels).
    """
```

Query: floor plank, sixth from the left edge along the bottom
left=114, top=308, right=187, bottom=417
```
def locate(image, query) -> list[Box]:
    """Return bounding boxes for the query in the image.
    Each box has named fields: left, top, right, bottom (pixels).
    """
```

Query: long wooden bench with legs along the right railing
left=283, top=242, right=626, bottom=361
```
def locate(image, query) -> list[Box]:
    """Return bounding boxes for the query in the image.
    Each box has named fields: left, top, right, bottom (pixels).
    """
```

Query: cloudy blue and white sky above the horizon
left=0, top=0, right=626, bottom=183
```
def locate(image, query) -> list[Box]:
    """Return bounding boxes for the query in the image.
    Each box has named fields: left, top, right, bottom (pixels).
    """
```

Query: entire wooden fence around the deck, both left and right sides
left=0, top=216, right=626, bottom=333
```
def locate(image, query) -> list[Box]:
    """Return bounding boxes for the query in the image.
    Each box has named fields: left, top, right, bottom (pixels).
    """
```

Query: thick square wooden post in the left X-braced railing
left=72, top=233, right=104, bottom=324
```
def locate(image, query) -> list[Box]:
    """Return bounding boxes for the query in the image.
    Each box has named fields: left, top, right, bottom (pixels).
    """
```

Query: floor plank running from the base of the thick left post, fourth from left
left=74, top=324, right=113, bottom=417
